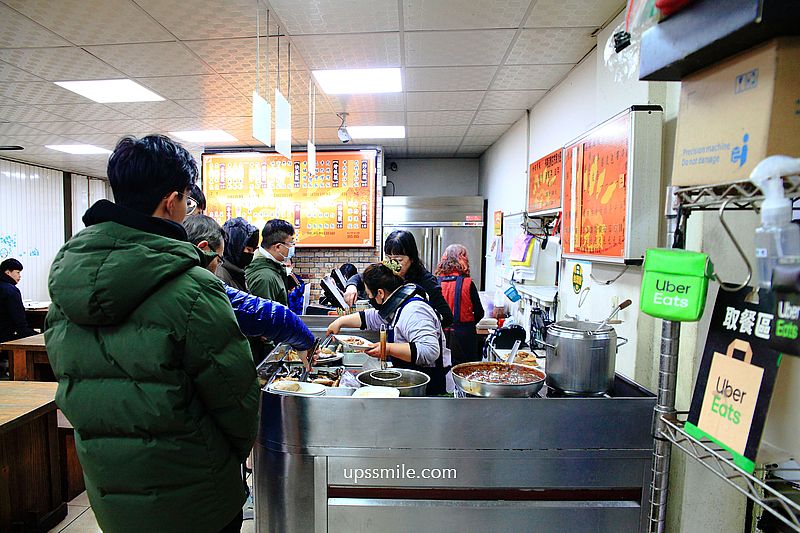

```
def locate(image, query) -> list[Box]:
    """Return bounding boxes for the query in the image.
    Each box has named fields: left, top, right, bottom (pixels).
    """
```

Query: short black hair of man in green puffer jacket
left=108, top=135, right=197, bottom=215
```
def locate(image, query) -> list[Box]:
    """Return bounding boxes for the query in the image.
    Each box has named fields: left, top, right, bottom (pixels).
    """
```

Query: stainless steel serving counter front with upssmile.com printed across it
left=254, top=376, right=655, bottom=533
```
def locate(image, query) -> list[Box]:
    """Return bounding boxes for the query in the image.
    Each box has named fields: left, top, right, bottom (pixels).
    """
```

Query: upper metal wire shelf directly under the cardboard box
left=674, top=176, right=800, bottom=211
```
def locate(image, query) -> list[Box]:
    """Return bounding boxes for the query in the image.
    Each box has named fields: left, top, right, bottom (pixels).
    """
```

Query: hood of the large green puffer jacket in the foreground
left=49, top=200, right=201, bottom=326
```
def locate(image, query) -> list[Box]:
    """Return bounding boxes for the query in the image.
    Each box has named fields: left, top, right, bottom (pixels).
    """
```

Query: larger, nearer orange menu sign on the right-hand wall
left=562, top=114, right=630, bottom=258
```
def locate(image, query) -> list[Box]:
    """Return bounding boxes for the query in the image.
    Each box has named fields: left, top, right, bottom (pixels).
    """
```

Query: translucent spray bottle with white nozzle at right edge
left=750, top=155, right=800, bottom=289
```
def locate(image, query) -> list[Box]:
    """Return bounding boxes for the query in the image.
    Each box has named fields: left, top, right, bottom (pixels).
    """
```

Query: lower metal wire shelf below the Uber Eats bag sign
left=660, top=416, right=800, bottom=532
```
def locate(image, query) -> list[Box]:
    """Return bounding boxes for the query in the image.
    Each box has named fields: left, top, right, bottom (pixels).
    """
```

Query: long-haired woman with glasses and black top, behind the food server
left=344, top=230, right=453, bottom=328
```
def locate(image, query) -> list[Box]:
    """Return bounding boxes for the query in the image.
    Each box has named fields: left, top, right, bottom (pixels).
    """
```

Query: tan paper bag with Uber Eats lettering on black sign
left=697, top=339, right=764, bottom=454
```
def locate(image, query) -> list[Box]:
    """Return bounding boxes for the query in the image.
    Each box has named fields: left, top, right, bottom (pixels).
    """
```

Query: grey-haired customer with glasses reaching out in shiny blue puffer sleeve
left=183, top=215, right=314, bottom=359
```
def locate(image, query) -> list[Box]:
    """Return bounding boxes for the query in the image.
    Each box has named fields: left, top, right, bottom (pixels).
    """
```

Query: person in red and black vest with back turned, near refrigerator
left=435, top=244, right=484, bottom=365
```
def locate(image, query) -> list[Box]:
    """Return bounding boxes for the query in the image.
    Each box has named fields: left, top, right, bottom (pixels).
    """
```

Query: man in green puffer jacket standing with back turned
left=45, top=135, right=259, bottom=533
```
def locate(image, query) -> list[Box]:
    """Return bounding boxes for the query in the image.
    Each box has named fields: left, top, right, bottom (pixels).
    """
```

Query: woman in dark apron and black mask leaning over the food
left=328, top=263, right=454, bottom=396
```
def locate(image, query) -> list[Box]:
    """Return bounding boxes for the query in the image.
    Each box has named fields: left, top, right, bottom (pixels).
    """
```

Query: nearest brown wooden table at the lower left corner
left=0, top=381, right=67, bottom=531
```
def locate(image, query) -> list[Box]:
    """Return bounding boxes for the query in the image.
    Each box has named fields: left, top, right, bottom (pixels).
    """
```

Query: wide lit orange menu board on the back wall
left=203, top=150, right=376, bottom=247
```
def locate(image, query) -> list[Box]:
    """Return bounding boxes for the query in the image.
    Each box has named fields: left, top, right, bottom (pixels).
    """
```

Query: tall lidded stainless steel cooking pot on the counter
left=539, top=320, right=628, bottom=396
